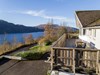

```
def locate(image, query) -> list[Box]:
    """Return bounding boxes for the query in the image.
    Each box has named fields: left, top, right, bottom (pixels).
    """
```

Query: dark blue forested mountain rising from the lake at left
left=0, top=20, right=44, bottom=34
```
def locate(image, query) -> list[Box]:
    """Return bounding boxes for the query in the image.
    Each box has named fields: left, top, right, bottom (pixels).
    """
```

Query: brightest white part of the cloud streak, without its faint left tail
left=20, top=10, right=73, bottom=22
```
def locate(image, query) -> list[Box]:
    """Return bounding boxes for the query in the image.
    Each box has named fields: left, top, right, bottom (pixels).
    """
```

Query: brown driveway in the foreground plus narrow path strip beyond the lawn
left=0, top=45, right=50, bottom=75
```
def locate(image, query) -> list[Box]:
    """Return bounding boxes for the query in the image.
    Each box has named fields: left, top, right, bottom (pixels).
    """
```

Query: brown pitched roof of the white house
left=76, top=10, right=100, bottom=27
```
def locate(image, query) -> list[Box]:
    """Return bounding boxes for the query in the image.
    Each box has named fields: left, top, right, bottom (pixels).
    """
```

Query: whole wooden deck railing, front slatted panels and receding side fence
left=51, top=34, right=100, bottom=75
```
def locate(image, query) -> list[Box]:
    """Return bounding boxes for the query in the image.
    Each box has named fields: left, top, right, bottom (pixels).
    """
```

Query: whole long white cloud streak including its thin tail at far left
left=3, top=10, right=74, bottom=23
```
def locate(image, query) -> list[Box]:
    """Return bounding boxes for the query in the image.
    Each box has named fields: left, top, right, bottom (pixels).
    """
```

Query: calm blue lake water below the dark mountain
left=0, top=32, right=44, bottom=44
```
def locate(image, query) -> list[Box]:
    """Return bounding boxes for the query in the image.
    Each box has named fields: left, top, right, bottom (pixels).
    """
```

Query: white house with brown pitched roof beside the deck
left=75, top=10, right=100, bottom=49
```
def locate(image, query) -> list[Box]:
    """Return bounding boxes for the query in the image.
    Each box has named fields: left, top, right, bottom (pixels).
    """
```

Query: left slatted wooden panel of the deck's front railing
left=53, top=47, right=75, bottom=72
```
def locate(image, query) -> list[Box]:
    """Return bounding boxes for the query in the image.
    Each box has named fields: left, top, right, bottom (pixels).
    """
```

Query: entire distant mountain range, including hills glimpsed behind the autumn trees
left=0, top=20, right=78, bottom=34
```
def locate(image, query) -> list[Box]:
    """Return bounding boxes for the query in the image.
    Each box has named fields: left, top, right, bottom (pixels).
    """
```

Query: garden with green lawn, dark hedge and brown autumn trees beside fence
left=15, top=23, right=67, bottom=60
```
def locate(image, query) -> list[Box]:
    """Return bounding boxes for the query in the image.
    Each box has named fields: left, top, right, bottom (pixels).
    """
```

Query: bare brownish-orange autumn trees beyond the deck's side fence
left=44, top=23, right=67, bottom=42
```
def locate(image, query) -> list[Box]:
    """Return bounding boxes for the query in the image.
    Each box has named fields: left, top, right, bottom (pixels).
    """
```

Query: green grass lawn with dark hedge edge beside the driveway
left=15, top=45, right=50, bottom=60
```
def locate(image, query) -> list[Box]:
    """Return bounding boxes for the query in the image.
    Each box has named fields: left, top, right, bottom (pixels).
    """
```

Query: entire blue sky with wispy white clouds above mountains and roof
left=0, top=0, right=100, bottom=27
